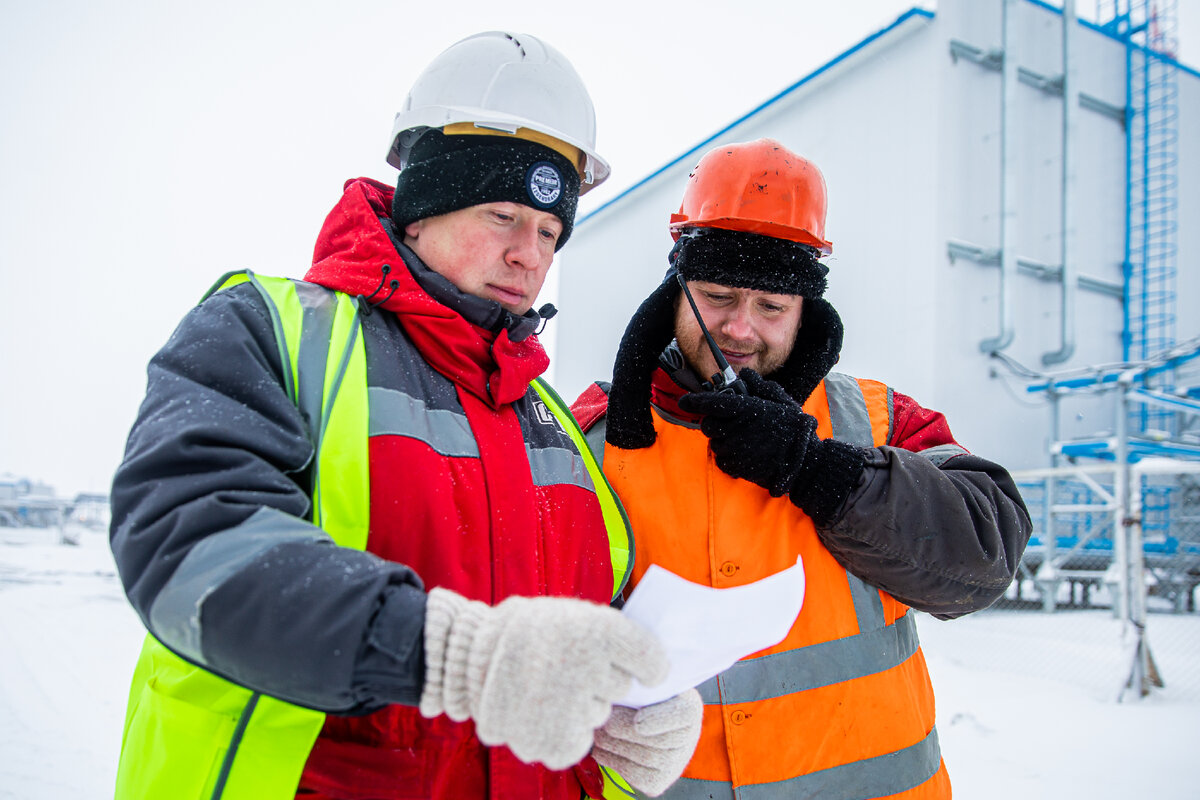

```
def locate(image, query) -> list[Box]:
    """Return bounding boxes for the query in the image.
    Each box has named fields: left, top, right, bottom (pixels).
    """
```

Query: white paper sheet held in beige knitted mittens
left=617, top=558, right=804, bottom=709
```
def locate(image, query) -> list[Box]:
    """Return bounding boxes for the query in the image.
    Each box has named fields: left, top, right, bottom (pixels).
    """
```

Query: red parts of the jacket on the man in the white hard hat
left=301, top=180, right=612, bottom=800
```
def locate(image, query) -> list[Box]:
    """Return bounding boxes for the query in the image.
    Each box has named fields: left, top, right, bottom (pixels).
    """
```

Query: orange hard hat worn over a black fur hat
left=671, top=139, right=833, bottom=255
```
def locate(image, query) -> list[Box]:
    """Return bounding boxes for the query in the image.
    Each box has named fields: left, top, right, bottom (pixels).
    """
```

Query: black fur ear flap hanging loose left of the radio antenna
left=605, top=269, right=679, bottom=450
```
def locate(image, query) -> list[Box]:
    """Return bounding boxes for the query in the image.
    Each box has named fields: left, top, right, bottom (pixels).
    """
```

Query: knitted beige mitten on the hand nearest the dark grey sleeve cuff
left=420, top=589, right=667, bottom=769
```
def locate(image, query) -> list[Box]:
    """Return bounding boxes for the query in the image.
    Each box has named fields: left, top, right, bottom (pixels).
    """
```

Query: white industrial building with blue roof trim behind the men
left=551, top=0, right=1200, bottom=469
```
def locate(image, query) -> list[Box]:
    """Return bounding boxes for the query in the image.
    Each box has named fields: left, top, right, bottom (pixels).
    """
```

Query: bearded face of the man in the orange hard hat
left=676, top=281, right=804, bottom=379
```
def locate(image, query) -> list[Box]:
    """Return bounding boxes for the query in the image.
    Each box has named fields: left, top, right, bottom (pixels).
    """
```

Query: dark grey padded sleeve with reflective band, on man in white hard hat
left=110, top=285, right=425, bottom=714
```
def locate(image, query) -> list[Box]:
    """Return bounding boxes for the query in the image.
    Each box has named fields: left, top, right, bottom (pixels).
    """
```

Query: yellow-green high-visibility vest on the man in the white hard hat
left=115, top=270, right=632, bottom=800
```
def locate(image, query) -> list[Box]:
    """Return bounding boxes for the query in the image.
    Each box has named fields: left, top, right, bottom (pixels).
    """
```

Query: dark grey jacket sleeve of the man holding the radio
left=817, top=446, right=1032, bottom=619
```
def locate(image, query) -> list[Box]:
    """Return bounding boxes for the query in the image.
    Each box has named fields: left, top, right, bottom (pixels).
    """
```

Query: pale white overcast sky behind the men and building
left=0, top=0, right=1200, bottom=494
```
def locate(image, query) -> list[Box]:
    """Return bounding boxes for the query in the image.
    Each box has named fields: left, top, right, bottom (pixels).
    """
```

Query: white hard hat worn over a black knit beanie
left=388, top=31, right=611, bottom=194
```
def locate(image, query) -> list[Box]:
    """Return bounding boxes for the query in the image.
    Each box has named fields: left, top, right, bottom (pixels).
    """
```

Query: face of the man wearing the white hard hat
left=404, top=203, right=563, bottom=314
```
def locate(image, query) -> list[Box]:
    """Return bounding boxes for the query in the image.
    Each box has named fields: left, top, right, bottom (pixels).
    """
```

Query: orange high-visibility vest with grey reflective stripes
left=604, top=374, right=950, bottom=800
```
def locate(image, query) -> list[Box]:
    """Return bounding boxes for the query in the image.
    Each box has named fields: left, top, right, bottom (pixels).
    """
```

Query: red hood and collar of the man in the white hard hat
left=305, top=178, right=550, bottom=408
